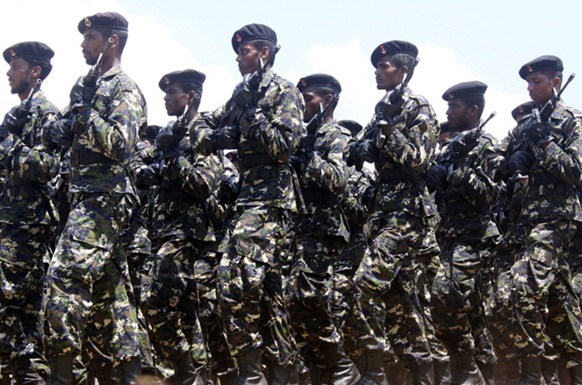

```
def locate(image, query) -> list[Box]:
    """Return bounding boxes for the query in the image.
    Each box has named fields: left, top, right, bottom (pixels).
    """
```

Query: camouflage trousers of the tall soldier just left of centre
left=217, top=206, right=297, bottom=366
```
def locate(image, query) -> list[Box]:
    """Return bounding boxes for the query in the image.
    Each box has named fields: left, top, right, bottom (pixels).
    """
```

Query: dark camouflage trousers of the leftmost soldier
left=0, top=224, right=55, bottom=374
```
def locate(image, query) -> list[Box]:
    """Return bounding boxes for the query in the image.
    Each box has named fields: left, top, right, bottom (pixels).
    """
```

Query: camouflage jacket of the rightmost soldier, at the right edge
left=507, top=101, right=582, bottom=223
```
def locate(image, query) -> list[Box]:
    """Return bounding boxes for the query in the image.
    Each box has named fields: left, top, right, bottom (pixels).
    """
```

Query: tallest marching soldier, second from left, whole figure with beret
left=46, top=12, right=146, bottom=384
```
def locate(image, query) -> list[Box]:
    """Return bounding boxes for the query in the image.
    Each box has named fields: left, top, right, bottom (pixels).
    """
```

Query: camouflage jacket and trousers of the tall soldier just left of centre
left=207, top=69, right=303, bottom=366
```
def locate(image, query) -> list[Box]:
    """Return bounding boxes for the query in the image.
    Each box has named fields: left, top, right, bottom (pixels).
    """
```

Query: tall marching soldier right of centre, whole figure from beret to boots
left=344, top=40, right=438, bottom=384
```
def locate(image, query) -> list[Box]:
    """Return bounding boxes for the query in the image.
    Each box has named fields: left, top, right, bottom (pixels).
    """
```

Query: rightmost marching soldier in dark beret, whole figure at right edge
left=500, top=55, right=582, bottom=384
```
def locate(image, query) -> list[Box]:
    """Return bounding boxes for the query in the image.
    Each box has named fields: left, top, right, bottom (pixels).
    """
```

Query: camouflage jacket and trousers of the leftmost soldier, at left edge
left=0, top=91, right=58, bottom=383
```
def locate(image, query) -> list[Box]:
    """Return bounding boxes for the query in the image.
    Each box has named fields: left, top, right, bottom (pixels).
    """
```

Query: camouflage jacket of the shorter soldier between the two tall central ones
left=297, top=121, right=350, bottom=242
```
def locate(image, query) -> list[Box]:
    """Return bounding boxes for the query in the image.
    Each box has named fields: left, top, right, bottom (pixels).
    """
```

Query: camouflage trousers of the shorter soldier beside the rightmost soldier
left=431, top=235, right=496, bottom=364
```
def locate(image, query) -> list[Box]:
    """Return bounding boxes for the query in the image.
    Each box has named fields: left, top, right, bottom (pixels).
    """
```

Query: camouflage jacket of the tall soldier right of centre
left=344, top=89, right=439, bottom=217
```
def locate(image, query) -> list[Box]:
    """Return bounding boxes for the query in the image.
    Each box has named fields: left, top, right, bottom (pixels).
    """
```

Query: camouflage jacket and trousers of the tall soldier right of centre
left=345, top=89, right=438, bottom=368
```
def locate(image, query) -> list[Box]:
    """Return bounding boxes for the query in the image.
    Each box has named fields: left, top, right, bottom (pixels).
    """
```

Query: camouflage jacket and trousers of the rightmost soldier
left=508, top=101, right=582, bottom=366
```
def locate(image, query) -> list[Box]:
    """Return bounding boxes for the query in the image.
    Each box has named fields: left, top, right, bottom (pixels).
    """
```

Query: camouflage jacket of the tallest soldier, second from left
left=71, top=66, right=147, bottom=195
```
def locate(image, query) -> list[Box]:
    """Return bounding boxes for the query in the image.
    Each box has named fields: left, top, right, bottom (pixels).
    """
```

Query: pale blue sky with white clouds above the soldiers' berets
left=0, top=0, right=582, bottom=138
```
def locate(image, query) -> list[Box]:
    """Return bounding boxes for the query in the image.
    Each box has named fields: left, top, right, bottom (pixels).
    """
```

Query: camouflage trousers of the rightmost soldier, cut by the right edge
left=511, top=219, right=582, bottom=365
